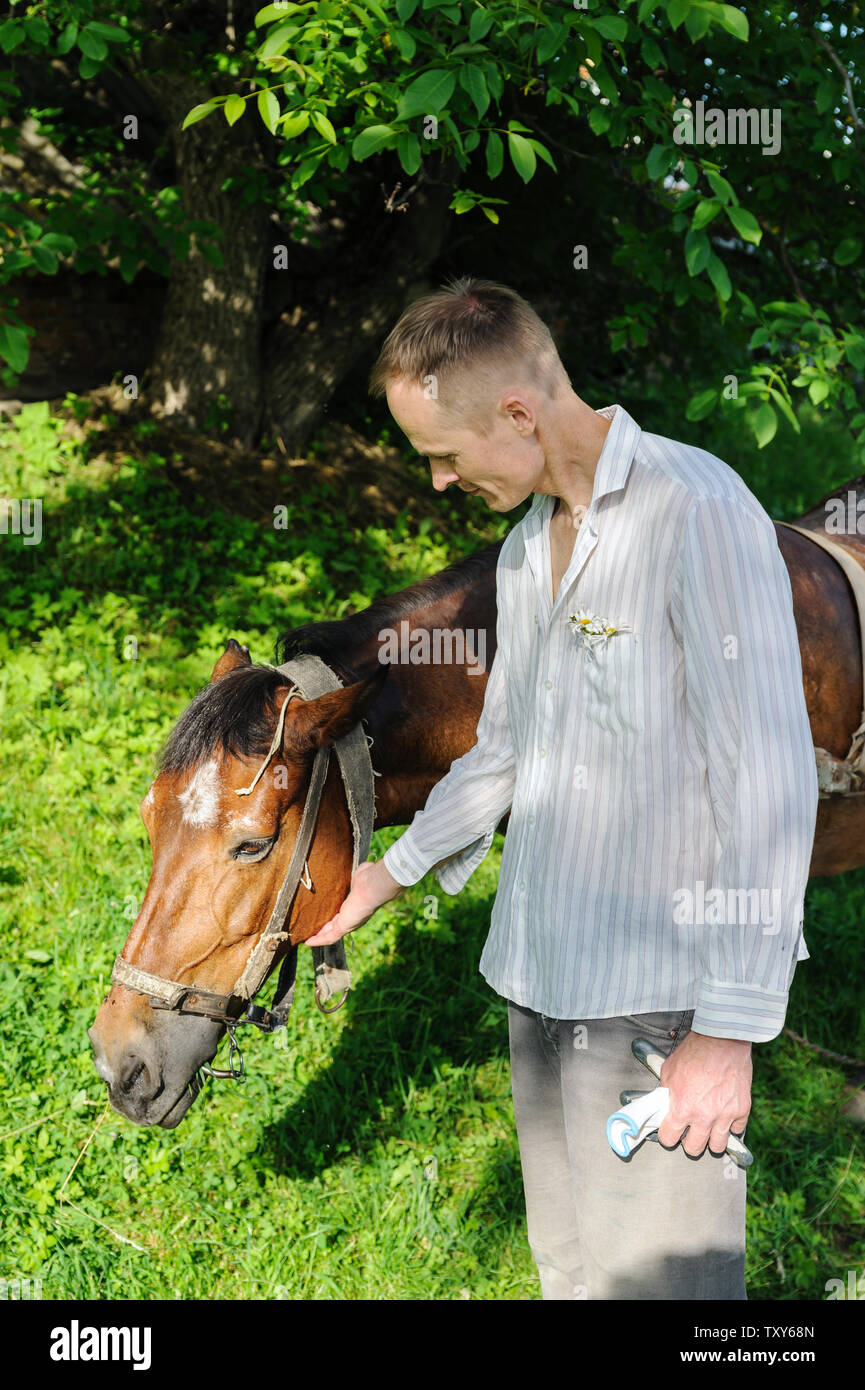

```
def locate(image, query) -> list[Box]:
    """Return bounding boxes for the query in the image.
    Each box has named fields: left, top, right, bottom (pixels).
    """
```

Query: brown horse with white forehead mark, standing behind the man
left=90, top=480, right=865, bottom=1129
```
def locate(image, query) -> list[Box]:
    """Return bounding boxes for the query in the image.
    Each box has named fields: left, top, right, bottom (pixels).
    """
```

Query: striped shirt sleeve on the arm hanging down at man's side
left=672, top=498, right=818, bottom=1043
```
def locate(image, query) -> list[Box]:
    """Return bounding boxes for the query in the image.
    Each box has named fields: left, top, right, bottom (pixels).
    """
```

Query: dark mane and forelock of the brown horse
left=159, top=541, right=502, bottom=773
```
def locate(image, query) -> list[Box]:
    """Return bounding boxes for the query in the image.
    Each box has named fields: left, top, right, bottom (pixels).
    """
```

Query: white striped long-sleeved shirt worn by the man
left=384, top=406, right=818, bottom=1041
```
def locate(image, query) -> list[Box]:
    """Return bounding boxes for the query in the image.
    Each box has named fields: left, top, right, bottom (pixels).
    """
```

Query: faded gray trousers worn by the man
left=508, top=1002, right=747, bottom=1300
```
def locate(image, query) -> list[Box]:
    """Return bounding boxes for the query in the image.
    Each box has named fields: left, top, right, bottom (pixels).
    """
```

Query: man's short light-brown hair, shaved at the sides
left=370, top=275, right=570, bottom=425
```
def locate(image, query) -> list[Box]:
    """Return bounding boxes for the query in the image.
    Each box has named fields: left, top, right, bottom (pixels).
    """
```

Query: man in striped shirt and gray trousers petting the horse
left=308, top=279, right=818, bottom=1300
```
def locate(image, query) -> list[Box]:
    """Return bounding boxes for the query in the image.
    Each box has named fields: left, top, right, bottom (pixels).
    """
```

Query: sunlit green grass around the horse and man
left=0, top=394, right=865, bottom=1300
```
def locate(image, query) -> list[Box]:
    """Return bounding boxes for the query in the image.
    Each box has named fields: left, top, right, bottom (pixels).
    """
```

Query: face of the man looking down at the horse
left=388, top=379, right=544, bottom=512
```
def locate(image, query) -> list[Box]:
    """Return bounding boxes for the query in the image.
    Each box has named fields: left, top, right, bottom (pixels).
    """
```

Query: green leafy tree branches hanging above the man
left=0, top=0, right=865, bottom=457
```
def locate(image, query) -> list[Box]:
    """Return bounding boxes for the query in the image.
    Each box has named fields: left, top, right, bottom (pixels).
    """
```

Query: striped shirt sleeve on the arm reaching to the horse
left=382, top=645, right=515, bottom=894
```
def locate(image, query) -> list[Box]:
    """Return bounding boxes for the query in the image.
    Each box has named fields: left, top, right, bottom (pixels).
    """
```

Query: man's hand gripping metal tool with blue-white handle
left=658, top=1033, right=752, bottom=1158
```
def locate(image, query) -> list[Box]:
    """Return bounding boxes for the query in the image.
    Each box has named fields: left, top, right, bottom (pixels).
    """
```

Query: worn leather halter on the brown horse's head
left=111, top=653, right=374, bottom=1045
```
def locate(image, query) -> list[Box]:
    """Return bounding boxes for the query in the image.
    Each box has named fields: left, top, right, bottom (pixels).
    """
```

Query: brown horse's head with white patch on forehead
left=89, top=639, right=387, bottom=1129
